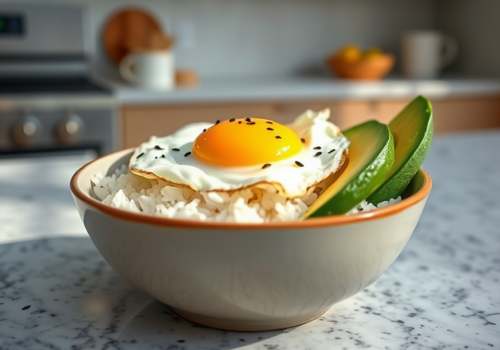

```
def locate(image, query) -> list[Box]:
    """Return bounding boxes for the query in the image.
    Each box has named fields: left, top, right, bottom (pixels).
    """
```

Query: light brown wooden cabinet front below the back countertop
left=121, top=96, right=500, bottom=147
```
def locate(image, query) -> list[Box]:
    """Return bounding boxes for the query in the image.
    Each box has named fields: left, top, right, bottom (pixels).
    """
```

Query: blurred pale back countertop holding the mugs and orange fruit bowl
left=100, top=78, right=500, bottom=104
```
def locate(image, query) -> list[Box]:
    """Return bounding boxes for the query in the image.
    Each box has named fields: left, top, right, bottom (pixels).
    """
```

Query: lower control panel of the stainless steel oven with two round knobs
left=0, top=98, right=117, bottom=157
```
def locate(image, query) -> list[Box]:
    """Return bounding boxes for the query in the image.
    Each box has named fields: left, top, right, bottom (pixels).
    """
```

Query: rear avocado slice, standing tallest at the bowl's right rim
left=367, top=96, right=433, bottom=204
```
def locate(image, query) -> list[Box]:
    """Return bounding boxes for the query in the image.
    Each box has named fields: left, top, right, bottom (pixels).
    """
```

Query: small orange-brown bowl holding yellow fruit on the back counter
left=327, top=54, right=394, bottom=80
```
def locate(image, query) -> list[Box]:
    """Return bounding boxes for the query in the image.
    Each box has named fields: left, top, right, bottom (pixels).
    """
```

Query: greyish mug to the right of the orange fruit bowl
left=401, top=30, right=458, bottom=79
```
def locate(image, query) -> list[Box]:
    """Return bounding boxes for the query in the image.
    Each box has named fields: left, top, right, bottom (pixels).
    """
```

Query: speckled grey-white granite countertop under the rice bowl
left=0, top=133, right=500, bottom=350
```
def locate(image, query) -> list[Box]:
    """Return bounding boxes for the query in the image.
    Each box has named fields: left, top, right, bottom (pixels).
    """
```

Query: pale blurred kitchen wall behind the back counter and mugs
left=10, top=0, right=500, bottom=77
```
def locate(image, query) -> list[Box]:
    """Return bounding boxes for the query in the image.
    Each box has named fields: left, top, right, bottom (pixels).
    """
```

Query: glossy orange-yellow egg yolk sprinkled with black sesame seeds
left=193, top=118, right=303, bottom=166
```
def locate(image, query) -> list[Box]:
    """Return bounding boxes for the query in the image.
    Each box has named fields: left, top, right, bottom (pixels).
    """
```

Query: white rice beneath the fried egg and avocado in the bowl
left=91, top=166, right=401, bottom=223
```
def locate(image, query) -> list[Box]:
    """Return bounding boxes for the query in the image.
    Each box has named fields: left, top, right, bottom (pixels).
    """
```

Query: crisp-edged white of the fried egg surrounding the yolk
left=129, top=110, right=349, bottom=197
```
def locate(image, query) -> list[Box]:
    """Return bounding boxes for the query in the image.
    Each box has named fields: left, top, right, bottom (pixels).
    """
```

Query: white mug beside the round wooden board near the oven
left=120, top=50, right=175, bottom=90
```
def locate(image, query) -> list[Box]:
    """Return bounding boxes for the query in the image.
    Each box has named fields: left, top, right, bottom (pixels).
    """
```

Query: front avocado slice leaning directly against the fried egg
left=304, top=120, right=394, bottom=218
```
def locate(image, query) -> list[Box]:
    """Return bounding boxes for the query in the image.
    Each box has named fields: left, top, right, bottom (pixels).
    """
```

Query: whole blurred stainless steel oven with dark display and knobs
left=0, top=2, right=119, bottom=158
